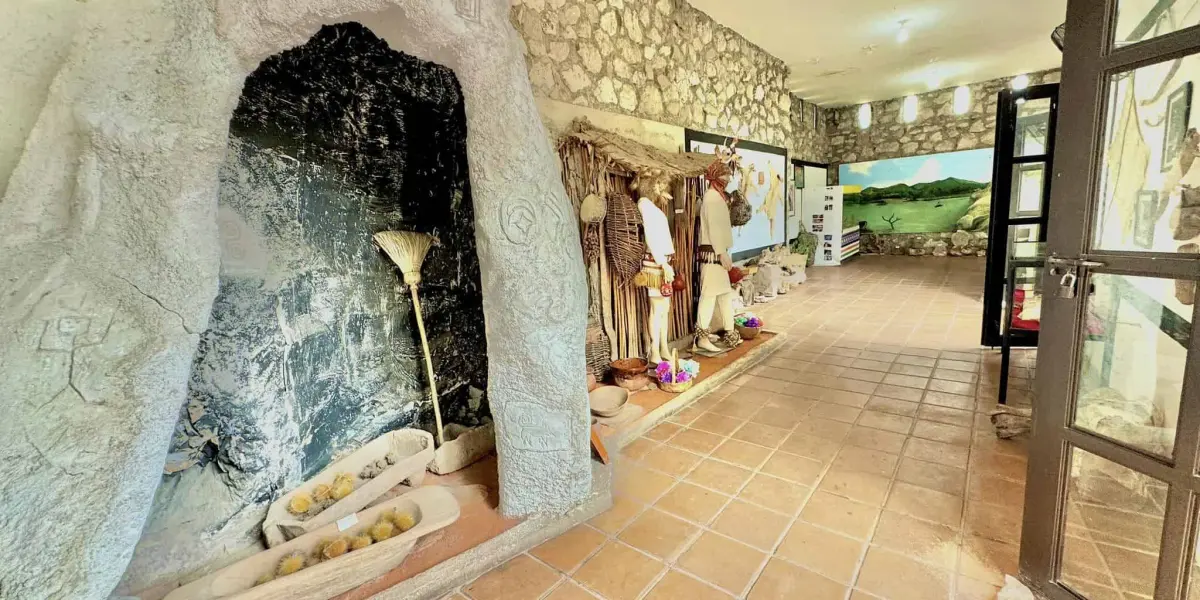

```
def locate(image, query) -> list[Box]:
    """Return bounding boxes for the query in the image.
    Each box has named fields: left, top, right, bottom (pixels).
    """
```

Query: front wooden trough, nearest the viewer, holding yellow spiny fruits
left=164, top=486, right=458, bottom=600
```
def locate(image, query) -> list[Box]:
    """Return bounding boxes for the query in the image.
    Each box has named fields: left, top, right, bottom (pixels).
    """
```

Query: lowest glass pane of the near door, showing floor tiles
left=1058, top=448, right=1166, bottom=600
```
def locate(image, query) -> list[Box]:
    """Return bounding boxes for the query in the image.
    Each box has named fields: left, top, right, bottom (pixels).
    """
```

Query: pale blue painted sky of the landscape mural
left=838, top=148, right=992, bottom=190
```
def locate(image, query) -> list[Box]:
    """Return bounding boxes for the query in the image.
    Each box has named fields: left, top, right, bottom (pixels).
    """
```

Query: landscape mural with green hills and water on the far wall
left=838, top=148, right=994, bottom=233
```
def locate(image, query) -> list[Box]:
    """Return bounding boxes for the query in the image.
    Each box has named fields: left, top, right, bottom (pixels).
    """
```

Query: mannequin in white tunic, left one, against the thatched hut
left=630, top=170, right=674, bottom=366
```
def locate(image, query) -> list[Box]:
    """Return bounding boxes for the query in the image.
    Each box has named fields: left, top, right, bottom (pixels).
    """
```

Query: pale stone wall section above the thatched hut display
left=511, top=0, right=796, bottom=152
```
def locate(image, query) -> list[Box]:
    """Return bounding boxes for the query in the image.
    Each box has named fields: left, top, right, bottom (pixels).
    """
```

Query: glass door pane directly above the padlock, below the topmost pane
left=1093, top=52, right=1200, bottom=253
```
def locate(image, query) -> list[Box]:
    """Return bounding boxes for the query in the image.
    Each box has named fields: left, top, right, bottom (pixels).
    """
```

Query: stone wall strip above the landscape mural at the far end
left=827, top=71, right=1060, bottom=169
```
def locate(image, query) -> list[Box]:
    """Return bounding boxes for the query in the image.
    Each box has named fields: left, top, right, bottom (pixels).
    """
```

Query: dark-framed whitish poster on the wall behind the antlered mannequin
left=685, top=130, right=788, bottom=254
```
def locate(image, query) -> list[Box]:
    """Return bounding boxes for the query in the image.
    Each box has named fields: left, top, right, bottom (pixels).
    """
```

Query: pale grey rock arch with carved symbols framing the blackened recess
left=0, top=0, right=590, bottom=600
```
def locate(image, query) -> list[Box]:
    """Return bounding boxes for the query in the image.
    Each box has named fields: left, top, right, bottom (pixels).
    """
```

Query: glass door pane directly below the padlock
left=1074, top=274, right=1192, bottom=457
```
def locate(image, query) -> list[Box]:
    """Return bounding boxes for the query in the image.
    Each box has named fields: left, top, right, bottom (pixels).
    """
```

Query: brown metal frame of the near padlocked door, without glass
left=1020, top=0, right=1200, bottom=600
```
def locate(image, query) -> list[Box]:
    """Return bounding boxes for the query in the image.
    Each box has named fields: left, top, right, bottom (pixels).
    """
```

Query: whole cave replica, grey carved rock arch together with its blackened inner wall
left=0, top=0, right=590, bottom=599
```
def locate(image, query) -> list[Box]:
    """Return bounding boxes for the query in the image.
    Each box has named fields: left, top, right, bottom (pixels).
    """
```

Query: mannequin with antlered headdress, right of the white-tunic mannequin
left=692, top=148, right=742, bottom=354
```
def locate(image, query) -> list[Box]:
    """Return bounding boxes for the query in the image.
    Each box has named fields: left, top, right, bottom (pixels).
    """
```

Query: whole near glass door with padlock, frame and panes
left=1021, top=0, right=1200, bottom=600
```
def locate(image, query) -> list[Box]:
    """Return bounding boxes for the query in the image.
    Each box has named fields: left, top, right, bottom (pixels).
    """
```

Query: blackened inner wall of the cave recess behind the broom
left=125, top=23, right=490, bottom=590
